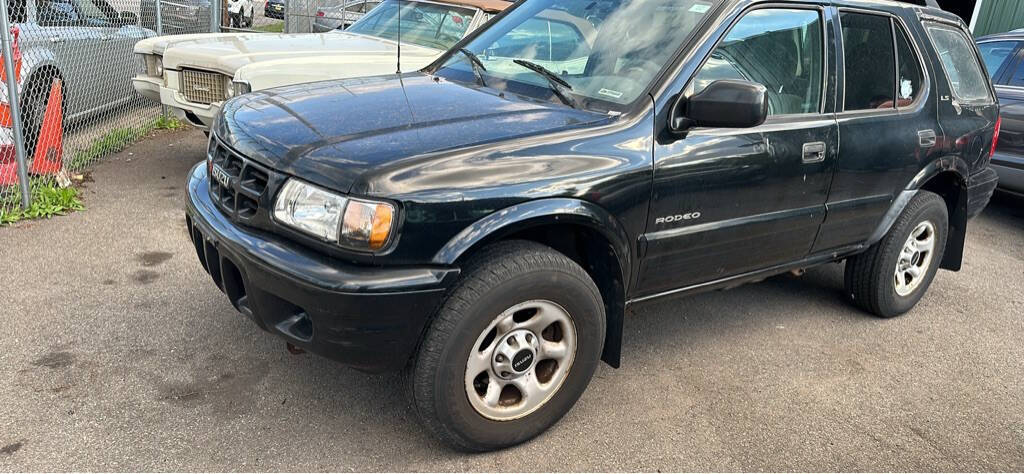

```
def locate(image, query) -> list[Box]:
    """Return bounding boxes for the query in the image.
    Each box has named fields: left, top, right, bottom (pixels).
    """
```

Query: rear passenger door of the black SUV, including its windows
left=814, top=8, right=940, bottom=253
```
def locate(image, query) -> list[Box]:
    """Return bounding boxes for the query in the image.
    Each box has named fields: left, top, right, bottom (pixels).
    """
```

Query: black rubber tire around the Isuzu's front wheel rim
left=407, top=241, right=605, bottom=451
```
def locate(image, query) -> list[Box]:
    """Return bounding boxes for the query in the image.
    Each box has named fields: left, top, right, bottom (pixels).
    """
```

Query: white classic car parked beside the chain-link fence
left=132, top=0, right=511, bottom=129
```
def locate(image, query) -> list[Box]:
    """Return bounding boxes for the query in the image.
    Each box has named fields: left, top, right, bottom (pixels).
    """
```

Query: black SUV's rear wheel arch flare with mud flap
left=866, top=157, right=970, bottom=271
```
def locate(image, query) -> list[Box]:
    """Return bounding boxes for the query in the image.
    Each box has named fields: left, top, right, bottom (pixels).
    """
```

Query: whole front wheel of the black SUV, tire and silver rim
left=409, top=241, right=605, bottom=451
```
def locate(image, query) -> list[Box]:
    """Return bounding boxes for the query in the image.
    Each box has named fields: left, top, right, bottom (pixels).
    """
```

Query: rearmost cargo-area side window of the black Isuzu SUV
left=928, top=24, right=991, bottom=101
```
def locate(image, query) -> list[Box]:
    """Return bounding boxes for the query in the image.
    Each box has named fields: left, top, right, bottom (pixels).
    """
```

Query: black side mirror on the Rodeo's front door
left=669, top=79, right=768, bottom=133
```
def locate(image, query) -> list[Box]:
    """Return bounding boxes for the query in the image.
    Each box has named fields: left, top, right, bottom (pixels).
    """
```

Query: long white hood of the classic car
left=164, top=32, right=440, bottom=76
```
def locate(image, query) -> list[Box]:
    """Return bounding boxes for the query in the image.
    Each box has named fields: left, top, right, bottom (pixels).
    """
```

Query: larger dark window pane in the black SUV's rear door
left=840, top=12, right=896, bottom=111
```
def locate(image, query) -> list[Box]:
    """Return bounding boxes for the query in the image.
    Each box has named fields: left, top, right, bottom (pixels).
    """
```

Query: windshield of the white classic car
left=345, top=0, right=475, bottom=49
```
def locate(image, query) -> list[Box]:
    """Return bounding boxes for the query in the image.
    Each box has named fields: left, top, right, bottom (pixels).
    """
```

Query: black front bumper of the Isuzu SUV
left=185, top=163, right=459, bottom=372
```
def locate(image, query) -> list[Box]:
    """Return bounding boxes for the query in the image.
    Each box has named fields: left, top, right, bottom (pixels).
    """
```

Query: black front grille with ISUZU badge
left=207, top=137, right=270, bottom=221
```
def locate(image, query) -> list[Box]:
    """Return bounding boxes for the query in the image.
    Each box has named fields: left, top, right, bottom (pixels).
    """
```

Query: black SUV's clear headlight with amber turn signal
left=273, top=179, right=394, bottom=251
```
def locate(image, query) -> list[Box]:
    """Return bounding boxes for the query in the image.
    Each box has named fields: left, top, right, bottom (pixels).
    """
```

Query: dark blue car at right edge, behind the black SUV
left=978, top=30, right=1024, bottom=195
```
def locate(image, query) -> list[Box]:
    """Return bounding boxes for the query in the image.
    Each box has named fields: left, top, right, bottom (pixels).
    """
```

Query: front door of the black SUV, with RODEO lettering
left=637, top=5, right=838, bottom=296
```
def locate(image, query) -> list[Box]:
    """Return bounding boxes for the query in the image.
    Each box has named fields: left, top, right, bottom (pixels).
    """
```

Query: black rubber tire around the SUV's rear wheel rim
left=845, top=190, right=949, bottom=317
